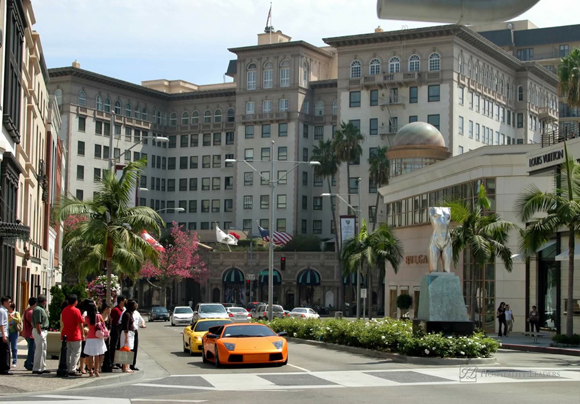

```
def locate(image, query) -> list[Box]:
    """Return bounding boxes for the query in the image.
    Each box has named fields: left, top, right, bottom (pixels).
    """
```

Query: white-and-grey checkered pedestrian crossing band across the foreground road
left=135, top=366, right=580, bottom=391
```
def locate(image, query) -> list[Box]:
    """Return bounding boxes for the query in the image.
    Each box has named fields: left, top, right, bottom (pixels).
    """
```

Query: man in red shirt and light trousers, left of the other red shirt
left=60, top=295, right=85, bottom=376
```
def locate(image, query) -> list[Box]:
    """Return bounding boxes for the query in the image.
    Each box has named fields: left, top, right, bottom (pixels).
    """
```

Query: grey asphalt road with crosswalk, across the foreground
left=0, top=323, right=580, bottom=404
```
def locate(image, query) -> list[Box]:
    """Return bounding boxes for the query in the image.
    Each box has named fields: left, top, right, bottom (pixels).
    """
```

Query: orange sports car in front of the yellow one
left=202, top=323, right=288, bottom=367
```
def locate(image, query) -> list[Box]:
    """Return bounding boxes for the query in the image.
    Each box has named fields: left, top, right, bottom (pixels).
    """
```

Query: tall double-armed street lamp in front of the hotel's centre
left=225, top=140, right=320, bottom=321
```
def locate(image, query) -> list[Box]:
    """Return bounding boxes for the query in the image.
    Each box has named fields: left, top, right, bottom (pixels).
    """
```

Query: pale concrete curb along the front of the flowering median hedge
left=286, top=338, right=497, bottom=366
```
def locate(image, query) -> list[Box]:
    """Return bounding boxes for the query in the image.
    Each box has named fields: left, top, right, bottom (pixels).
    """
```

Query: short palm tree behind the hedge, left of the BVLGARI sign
left=340, top=219, right=403, bottom=317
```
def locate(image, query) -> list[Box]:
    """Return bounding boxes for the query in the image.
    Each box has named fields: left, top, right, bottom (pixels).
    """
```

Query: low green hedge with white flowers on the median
left=265, top=318, right=499, bottom=358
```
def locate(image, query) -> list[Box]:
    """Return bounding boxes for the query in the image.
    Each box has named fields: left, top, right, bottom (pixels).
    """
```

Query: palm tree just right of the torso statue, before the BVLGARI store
left=443, top=184, right=516, bottom=326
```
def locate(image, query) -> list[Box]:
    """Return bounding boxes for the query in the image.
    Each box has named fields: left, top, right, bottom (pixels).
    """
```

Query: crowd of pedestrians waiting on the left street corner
left=0, top=294, right=146, bottom=377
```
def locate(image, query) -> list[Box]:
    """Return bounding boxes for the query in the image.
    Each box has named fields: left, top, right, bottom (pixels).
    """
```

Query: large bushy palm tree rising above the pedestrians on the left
left=59, top=159, right=163, bottom=302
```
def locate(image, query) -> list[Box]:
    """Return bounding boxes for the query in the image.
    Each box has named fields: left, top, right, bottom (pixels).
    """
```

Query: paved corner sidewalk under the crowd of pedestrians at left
left=0, top=338, right=148, bottom=396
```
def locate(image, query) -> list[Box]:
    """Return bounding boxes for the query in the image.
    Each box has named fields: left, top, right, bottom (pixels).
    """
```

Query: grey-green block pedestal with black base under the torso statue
left=413, top=272, right=473, bottom=335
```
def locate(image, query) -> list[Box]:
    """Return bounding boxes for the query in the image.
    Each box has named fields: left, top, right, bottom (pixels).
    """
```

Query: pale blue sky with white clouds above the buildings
left=32, top=0, right=580, bottom=84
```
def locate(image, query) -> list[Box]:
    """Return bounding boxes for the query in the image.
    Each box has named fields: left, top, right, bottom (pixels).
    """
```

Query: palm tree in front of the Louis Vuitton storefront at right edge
left=516, top=143, right=580, bottom=337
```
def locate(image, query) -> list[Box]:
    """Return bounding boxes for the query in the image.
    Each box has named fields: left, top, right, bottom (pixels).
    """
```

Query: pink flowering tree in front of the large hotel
left=140, top=222, right=209, bottom=306
